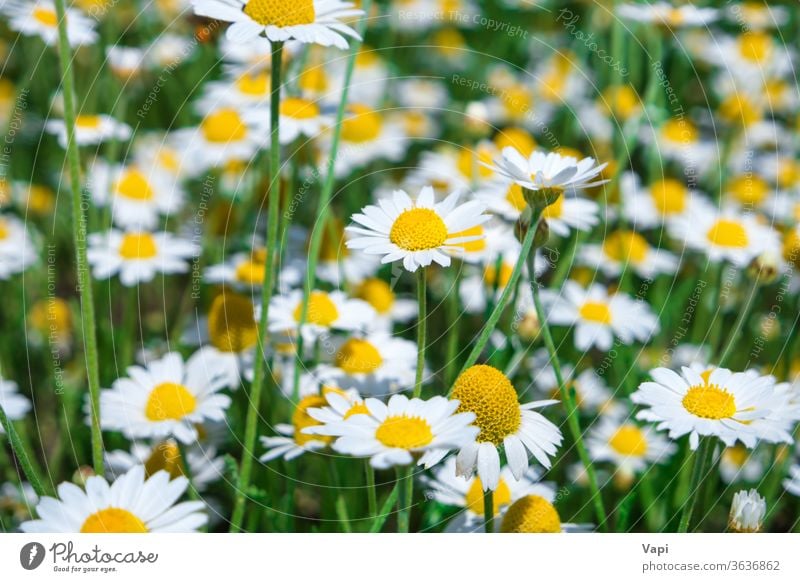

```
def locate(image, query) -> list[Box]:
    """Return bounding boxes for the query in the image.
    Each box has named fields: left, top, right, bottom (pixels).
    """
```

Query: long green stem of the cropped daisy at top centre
left=228, top=41, right=283, bottom=532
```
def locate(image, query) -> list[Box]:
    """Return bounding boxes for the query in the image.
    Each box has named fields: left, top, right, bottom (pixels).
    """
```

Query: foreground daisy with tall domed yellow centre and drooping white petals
left=451, top=365, right=562, bottom=491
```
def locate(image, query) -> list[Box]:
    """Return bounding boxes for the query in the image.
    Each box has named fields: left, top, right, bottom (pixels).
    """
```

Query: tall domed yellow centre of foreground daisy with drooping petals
left=451, top=364, right=522, bottom=445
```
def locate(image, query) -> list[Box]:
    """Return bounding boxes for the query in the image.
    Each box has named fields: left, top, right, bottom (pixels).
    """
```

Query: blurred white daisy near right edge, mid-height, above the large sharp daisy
left=670, top=208, right=780, bottom=267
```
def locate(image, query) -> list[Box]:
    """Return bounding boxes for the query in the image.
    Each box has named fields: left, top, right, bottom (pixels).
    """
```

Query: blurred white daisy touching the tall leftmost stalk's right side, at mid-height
left=87, top=229, right=198, bottom=287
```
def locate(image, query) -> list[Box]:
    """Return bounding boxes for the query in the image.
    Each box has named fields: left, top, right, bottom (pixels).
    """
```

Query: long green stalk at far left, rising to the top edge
left=55, top=0, right=105, bottom=475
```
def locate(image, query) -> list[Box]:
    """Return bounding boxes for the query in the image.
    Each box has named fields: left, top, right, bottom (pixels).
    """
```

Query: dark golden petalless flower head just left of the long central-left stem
left=208, top=291, right=258, bottom=353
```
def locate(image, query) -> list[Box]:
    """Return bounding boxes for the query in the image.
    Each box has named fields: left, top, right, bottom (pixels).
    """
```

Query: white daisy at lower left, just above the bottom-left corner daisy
left=100, top=352, right=231, bottom=444
